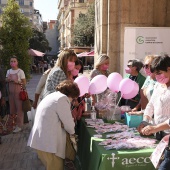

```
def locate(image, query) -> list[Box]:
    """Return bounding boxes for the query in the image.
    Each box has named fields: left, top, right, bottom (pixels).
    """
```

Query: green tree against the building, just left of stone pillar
left=73, top=4, right=95, bottom=46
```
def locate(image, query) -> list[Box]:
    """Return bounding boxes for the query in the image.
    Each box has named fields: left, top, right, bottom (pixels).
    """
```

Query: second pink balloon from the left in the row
left=89, top=75, right=107, bottom=94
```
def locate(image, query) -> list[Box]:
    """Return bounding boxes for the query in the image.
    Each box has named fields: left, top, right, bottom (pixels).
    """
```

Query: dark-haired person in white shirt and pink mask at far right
left=138, top=55, right=170, bottom=139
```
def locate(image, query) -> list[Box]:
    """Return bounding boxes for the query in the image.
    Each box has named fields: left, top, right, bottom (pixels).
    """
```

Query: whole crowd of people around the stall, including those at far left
left=0, top=49, right=170, bottom=170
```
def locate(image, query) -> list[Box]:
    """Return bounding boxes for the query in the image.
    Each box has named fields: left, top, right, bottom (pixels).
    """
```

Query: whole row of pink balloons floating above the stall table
left=74, top=72, right=139, bottom=99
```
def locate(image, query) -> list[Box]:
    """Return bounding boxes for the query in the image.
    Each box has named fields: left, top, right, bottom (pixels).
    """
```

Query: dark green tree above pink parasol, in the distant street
left=29, top=29, right=52, bottom=53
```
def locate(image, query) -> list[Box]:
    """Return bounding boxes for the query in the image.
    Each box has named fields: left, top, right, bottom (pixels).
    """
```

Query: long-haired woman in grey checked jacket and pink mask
left=43, top=49, right=77, bottom=98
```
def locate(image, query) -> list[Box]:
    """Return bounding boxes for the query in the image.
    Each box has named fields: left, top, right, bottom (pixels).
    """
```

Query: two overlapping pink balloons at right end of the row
left=119, top=78, right=139, bottom=99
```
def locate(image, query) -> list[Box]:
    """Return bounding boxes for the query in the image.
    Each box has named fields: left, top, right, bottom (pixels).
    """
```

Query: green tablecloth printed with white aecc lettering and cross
left=78, top=118, right=155, bottom=170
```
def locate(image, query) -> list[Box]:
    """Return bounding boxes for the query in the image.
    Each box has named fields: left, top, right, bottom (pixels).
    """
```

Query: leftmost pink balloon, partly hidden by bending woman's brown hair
left=74, top=75, right=90, bottom=96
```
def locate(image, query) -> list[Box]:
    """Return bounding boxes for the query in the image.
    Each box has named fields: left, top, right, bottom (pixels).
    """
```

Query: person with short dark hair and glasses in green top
left=121, top=59, right=146, bottom=109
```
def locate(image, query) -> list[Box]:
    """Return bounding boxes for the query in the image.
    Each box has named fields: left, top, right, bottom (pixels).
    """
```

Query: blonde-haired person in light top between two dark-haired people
left=128, top=55, right=157, bottom=115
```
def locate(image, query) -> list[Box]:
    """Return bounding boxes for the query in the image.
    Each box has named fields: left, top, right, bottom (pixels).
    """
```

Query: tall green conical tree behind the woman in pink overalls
left=0, top=0, right=32, bottom=78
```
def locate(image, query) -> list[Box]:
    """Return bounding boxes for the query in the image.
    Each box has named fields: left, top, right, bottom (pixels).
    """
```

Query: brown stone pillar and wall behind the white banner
left=95, top=0, right=170, bottom=73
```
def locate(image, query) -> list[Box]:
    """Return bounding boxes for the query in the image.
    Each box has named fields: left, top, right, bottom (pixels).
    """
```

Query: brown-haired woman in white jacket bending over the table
left=28, top=80, right=80, bottom=170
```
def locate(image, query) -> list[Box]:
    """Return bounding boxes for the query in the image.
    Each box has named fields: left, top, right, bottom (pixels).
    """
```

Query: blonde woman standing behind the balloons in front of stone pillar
left=90, top=54, right=110, bottom=106
